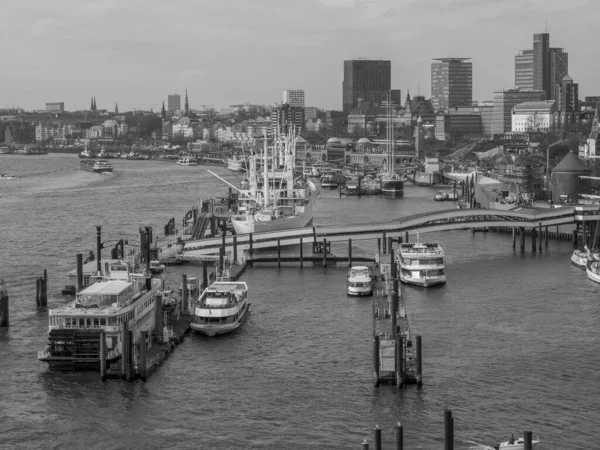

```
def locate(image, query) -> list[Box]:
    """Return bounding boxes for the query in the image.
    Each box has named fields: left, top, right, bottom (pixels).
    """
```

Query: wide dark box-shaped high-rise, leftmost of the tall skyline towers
left=342, top=59, right=392, bottom=112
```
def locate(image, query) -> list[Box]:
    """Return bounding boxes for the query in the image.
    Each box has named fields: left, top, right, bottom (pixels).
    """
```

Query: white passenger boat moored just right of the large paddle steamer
left=190, top=279, right=250, bottom=336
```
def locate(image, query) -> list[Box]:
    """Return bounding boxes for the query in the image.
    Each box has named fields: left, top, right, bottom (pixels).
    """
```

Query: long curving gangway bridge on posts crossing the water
left=177, top=205, right=600, bottom=260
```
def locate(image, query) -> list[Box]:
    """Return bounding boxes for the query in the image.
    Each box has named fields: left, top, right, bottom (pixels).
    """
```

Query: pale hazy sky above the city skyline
left=0, top=0, right=600, bottom=111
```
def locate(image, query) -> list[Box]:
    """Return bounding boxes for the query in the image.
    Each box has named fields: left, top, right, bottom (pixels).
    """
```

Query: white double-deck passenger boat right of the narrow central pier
left=396, top=242, right=446, bottom=287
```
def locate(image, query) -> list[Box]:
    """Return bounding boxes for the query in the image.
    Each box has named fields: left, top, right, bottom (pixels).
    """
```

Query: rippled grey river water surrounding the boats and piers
left=0, top=154, right=600, bottom=449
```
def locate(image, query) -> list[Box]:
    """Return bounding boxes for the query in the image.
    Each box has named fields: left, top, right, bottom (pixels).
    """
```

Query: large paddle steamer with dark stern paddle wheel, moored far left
left=38, top=260, right=161, bottom=370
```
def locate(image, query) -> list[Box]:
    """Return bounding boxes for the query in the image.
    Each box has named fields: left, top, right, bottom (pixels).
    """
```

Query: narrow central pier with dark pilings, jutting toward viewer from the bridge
left=373, top=246, right=422, bottom=388
